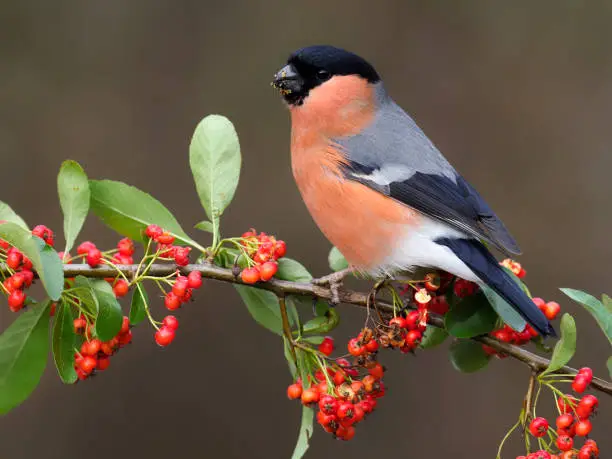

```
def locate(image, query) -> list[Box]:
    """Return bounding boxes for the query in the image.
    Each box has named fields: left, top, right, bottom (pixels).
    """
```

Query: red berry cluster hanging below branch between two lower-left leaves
left=74, top=315, right=132, bottom=381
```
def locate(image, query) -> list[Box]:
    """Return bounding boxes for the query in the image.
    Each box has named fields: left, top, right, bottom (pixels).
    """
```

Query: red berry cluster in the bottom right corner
left=517, top=367, right=599, bottom=459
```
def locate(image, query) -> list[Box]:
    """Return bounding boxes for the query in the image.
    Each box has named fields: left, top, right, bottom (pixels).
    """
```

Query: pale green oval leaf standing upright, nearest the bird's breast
left=189, top=115, right=242, bottom=241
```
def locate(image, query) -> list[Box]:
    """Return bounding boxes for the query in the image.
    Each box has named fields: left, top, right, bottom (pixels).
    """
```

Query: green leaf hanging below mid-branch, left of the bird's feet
left=234, top=285, right=297, bottom=335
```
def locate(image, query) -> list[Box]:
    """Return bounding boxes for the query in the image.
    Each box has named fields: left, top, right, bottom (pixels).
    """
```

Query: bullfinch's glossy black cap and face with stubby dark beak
left=272, top=45, right=380, bottom=105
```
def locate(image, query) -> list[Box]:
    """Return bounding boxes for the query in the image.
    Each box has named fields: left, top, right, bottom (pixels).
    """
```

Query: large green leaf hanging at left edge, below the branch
left=0, top=300, right=51, bottom=414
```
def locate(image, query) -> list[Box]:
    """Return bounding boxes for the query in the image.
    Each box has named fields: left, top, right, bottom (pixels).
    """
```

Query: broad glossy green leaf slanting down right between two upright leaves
left=89, top=180, right=204, bottom=251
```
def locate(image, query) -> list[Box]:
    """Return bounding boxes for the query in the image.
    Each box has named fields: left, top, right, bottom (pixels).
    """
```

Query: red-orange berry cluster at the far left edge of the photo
left=0, top=225, right=54, bottom=312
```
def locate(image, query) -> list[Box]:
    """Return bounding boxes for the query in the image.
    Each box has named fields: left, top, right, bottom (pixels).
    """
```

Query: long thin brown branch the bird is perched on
left=0, top=264, right=612, bottom=395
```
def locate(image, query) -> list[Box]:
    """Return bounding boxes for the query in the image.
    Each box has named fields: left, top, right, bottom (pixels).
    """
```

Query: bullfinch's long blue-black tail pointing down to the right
left=436, top=238, right=556, bottom=337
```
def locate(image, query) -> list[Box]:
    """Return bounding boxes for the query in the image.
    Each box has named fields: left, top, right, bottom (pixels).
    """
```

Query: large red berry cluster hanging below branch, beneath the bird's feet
left=287, top=328, right=385, bottom=440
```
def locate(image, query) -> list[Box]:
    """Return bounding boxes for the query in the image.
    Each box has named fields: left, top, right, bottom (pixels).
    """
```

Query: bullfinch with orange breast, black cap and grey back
left=271, top=45, right=556, bottom=337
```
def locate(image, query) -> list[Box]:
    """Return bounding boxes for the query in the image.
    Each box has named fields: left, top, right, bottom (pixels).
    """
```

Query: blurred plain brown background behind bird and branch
left=0, top=0, right=612, bottom=459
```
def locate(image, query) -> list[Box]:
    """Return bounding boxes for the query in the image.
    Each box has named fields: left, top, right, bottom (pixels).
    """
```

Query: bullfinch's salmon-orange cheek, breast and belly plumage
left=291, top=77, right=418, bottom=270
